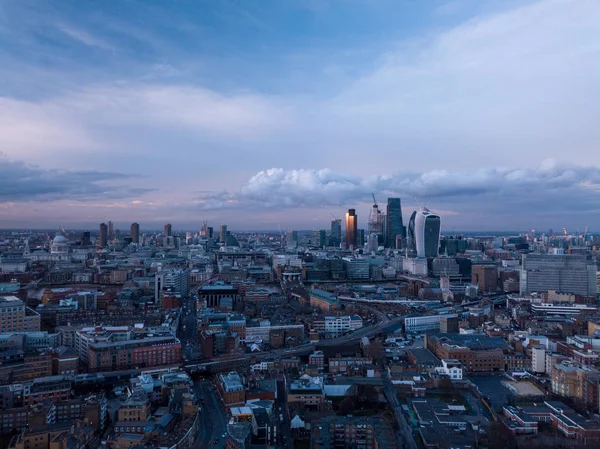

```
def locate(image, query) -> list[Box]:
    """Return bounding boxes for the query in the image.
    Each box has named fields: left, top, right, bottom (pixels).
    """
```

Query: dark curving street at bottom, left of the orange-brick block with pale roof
left=193, top=380, right=227, bottom=449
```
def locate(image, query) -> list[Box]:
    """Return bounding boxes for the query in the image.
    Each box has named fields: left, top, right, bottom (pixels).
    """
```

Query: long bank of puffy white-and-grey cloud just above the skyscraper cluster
left=196, top=160, right=600, bottom=213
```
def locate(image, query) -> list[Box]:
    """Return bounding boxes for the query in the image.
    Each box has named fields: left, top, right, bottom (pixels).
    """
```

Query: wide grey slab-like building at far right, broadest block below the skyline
left=520, top=254, right=597, bottom=298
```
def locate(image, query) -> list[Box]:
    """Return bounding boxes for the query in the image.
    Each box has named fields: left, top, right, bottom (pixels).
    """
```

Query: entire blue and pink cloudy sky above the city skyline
left=0, top=0, right=600, bottom=232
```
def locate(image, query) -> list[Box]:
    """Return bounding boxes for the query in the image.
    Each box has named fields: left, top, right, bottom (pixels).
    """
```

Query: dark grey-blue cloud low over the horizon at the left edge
left=0, top=157, right=150, bottom=203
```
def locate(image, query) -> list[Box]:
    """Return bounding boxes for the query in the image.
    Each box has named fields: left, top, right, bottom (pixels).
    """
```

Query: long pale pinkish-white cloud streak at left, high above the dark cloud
left=0, top=82, right=293, bottom=161
